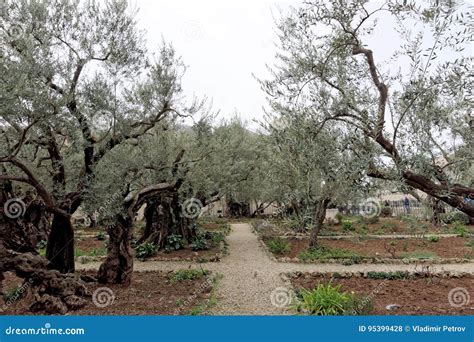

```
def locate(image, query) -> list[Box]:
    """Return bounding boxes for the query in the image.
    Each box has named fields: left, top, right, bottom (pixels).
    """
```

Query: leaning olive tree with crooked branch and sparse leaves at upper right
left=262, top=0, right=474, bottom=218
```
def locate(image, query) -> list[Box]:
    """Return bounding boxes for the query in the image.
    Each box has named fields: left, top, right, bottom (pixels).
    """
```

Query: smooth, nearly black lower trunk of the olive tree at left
left=46, top=213, right=75, bottom=273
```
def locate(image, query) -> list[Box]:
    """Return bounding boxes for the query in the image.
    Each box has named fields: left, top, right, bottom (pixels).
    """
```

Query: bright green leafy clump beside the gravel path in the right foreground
left=294, top=283, right=373, bottom=316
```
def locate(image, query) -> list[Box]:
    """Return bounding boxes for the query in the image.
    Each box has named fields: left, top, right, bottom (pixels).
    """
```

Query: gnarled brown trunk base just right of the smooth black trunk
left=97, top=214, right=133, bottom=286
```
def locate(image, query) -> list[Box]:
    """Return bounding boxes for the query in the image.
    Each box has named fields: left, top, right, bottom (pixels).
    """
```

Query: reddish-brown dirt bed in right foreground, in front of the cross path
left=291, top=273, right=474, bottom=315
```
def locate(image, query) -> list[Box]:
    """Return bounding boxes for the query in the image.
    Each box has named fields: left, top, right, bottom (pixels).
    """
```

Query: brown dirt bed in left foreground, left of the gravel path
left=0, top=272, right=212, bottom=315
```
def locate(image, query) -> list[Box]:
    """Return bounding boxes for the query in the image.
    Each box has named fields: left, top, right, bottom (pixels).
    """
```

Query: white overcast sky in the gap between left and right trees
left=132, top=0, right=295, bottom=127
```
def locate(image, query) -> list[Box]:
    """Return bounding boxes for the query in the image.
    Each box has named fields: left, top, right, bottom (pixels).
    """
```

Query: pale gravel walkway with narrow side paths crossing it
left=77, top=223, right=474, bottom=315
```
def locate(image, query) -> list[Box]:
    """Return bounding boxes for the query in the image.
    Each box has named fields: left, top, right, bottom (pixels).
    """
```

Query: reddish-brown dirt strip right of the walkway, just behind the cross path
left=274, top=237, right=473, bottom=258
